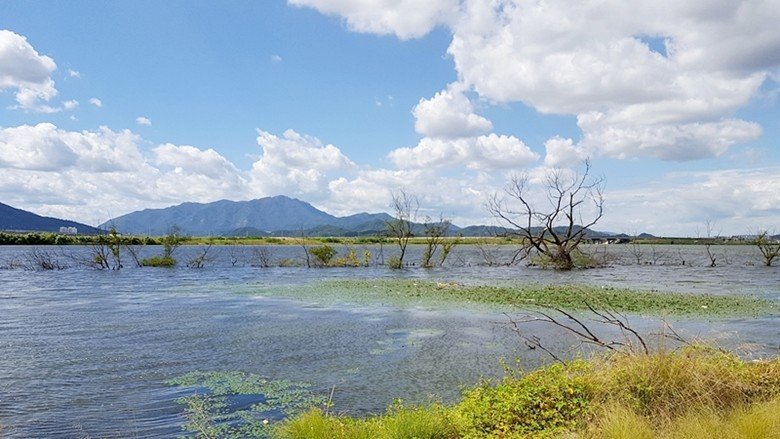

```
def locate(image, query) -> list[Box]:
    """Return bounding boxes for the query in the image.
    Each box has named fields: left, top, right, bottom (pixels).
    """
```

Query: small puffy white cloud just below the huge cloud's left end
left=412, top=82, right=493, bottom=138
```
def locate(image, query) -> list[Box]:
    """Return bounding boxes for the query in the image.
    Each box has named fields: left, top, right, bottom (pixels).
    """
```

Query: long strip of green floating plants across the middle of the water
left=259, top=279, right=778, bottom=317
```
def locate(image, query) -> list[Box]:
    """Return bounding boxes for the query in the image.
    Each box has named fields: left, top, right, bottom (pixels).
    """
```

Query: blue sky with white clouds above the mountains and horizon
left=0, top=0, right=780, bottom=236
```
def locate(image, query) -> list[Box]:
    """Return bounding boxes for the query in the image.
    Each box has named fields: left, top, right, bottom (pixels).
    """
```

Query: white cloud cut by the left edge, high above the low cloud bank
left=0, top=30, right=57, bottom=113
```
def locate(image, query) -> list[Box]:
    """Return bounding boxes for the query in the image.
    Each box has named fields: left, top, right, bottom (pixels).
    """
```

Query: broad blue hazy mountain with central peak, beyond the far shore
left=101, top=195, right=390, bottom=236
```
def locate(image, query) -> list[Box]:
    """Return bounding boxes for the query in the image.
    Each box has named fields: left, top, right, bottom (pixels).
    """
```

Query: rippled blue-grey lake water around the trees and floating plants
left=0, top=246, right=780, bottom=438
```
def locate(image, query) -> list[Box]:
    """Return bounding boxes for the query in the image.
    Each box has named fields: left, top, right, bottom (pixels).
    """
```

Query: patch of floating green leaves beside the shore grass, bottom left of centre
left=165, top=371, right=325, bottom=438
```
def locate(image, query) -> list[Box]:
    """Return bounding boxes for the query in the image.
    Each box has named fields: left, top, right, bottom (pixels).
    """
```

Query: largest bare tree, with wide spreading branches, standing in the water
left=487, top=160, right=604, bottom=270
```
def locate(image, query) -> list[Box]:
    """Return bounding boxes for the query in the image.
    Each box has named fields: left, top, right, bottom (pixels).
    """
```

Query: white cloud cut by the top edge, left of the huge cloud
left=288, top=0, right=459, bottom=40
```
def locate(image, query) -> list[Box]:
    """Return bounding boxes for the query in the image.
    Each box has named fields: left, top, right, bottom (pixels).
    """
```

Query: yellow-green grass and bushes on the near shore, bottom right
left=272, top=346, right=780, bottom=439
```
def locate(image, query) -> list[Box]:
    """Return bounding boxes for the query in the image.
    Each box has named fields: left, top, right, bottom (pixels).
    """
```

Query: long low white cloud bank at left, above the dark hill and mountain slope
left=0, top=123, right=247, bottom=224
